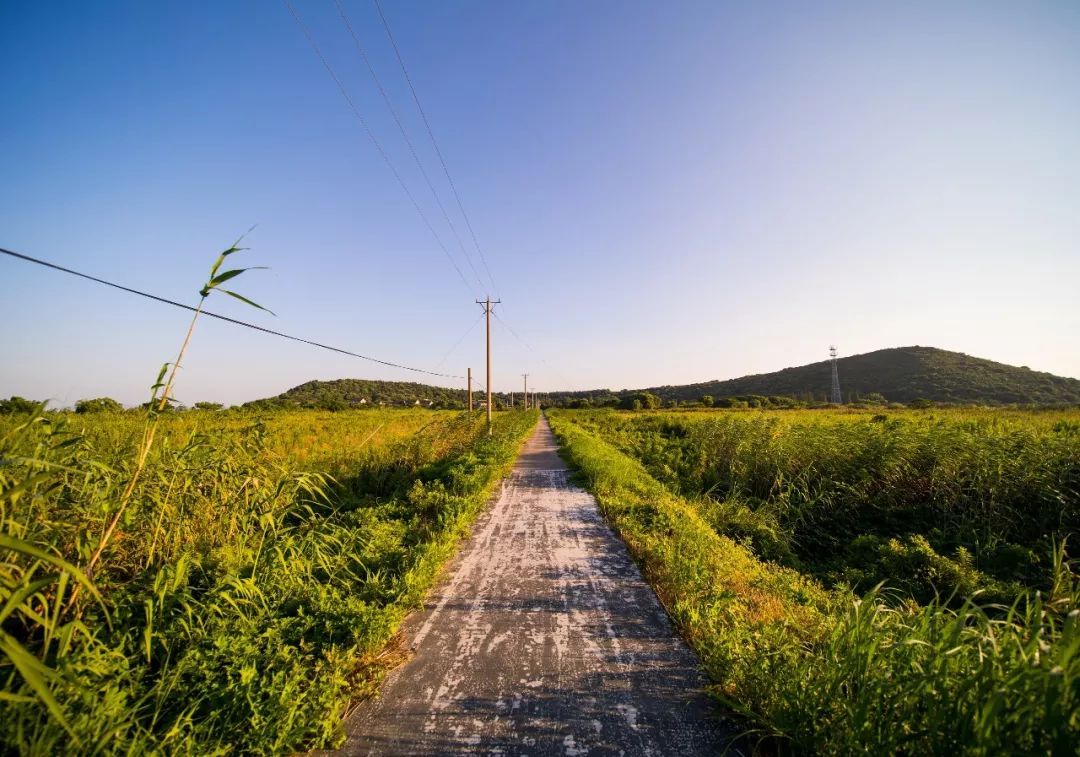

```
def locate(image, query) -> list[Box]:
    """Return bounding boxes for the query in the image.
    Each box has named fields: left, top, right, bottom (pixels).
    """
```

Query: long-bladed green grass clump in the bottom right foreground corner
left=765, top=564, right=1080, bottom=755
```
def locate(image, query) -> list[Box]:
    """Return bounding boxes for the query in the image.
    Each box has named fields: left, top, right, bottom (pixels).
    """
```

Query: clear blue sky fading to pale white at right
left=0, top=0, right=1080, bottom=404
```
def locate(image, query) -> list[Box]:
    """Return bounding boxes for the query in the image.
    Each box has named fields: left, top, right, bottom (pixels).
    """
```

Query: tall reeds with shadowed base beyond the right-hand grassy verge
left=578, top=410, right=1080, bottom=604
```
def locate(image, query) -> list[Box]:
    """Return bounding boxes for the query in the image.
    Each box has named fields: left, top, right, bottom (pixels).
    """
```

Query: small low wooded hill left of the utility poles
left=245, top=379, right=505, bottom=409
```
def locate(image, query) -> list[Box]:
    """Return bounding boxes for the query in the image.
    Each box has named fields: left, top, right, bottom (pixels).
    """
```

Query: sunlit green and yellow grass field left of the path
left=0, top=403, right=536, bottom=755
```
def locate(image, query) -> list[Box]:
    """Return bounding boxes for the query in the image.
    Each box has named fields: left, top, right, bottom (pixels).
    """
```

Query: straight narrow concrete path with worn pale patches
left=334, top=419, right=733, bottom=755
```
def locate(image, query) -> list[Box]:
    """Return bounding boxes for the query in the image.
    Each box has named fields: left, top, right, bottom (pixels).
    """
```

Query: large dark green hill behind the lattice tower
left=552, top=347, right=1080, bottom=405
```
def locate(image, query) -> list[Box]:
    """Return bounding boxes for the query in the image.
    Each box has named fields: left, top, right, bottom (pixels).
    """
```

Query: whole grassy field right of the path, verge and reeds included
left=550, top=409, right=1080, bottom=754
